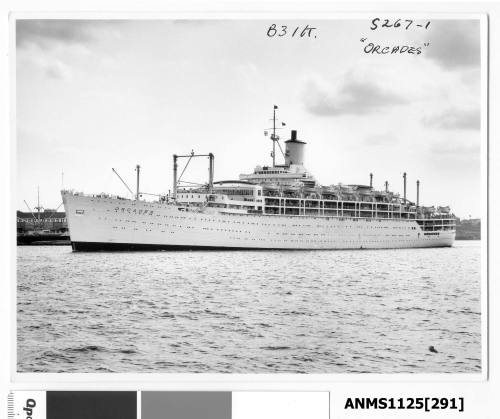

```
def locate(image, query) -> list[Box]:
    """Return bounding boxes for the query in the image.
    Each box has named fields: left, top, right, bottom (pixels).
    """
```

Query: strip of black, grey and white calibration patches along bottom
left=8, top=391, right=330, bottom=419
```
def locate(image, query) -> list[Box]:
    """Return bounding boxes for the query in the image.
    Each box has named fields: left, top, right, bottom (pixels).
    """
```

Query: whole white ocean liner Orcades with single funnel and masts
left=61, top=106, right=455, bottom=251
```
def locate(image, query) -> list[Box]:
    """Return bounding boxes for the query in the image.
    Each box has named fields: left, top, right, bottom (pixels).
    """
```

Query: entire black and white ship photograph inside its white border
left=13, top=18, right=487, bottom=376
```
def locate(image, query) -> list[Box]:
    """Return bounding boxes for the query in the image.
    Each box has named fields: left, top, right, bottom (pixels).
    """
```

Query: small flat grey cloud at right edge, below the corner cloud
left=422, top=108, right=481, bottom=130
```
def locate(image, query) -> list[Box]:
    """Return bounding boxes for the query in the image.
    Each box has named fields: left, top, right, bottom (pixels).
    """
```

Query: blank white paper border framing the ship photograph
left=9, top=4, right=491, bottom=390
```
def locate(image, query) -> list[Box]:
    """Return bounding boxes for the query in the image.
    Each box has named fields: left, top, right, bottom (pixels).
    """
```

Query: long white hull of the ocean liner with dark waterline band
left=62, top=192, right=455, bottom=251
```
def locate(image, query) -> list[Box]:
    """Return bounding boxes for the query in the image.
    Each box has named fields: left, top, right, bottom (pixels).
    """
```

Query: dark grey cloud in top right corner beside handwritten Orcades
left=426, top=20, right=480, bottom=69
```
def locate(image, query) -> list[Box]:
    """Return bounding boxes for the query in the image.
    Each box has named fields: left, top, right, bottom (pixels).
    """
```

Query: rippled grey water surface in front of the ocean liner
left=17, top=241, right=481, bottom=373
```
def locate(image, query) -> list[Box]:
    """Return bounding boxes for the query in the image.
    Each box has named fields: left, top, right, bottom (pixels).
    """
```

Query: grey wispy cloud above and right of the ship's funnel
left=302, top=73, right=408, bottom=116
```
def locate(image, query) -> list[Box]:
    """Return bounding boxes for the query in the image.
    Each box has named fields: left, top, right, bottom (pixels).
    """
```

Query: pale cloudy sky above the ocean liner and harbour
left=16, top=19, right=485, bottom=218
